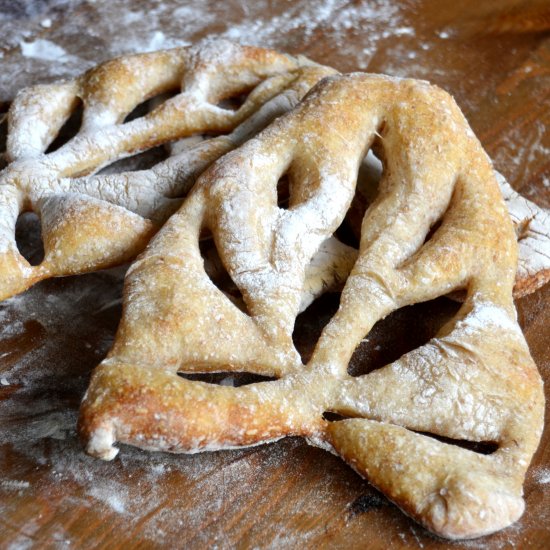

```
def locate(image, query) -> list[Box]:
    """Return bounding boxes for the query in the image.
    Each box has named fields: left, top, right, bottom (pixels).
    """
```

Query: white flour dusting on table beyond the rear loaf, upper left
left=0, top=0, right=406, bottom=100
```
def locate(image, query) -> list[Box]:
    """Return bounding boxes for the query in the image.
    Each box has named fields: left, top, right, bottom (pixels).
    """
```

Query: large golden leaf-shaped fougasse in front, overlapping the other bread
left=79, top=74, right=544, bottom=538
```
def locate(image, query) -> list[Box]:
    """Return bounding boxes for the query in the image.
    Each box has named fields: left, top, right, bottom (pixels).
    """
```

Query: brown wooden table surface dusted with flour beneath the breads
left=0, top=0, right=550, bottom=549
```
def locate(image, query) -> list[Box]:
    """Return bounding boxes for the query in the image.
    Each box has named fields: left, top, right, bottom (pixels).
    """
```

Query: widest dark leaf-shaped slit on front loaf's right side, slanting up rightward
left=348, top=296, right=461, bottom=376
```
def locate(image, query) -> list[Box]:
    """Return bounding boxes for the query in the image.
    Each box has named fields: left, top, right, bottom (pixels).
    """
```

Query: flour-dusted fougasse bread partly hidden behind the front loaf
left=0, top=40, right=335, bottom=299
